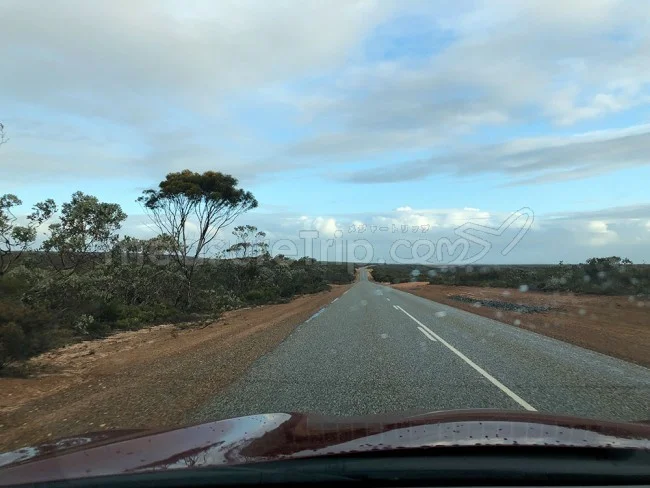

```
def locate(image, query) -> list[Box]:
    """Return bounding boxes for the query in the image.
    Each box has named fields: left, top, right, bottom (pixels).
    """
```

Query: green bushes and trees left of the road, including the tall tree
left=0, top=170, right=354, bottom=375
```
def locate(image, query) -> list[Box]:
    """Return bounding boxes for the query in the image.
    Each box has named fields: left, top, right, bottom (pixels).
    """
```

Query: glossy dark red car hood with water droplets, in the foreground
left=0, top=410, right=650, bottom=485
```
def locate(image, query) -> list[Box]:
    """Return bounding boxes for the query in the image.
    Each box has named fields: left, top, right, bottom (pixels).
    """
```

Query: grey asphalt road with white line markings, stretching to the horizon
left=192, top=269, right=650, bottom=420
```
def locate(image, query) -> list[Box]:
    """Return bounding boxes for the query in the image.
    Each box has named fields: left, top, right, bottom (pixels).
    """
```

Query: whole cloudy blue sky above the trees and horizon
left=0, top=0, right=650, bottom=264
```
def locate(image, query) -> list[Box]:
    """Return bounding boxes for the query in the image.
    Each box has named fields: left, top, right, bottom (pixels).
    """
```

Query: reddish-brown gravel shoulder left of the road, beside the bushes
left=0, top=285, right=351, bottom=452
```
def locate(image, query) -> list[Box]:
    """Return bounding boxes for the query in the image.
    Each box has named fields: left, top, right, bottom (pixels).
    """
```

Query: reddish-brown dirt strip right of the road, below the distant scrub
left=392, top=282, right=650, bottom=367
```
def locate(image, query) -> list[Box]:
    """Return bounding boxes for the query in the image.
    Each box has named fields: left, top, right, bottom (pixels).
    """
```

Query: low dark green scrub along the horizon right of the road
left=372, top=262, right=650, bottom=295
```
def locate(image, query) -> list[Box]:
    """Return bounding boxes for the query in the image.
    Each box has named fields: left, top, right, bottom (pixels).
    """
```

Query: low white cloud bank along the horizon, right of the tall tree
left=197, top=205, right=650, bottom=265
